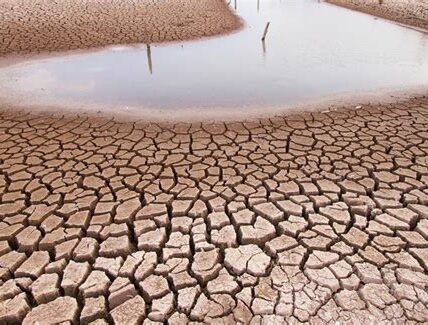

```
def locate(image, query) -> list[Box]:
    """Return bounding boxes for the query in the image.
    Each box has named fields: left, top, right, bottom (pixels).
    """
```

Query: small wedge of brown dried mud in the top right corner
left=327, top=0, right=428, bottom=31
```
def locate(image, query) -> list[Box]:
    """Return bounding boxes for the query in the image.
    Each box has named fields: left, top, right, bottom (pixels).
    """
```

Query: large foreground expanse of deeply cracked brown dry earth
left=0, top=97, right=428, bottom=324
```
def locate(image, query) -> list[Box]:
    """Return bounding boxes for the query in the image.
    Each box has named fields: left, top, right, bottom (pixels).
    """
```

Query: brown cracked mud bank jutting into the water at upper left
left=0, top=0, right=241, bottom=55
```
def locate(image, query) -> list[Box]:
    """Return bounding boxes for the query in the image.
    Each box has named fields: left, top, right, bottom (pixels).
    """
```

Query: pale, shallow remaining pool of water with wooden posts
left=0, top=0, right=428, bottom=115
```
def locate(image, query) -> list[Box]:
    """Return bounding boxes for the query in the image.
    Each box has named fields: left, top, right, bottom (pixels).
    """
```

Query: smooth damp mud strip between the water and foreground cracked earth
left=0, top=86, right=428, bottom=123
